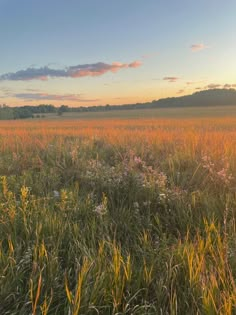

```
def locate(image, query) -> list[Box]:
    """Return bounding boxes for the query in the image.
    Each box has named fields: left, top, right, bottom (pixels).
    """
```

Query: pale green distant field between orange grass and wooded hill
left=33, top=106, right=236, bottom=119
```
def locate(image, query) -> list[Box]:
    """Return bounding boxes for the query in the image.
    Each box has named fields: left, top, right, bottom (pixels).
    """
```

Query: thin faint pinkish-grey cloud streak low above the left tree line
left=12, top=93, right=100, bottom=102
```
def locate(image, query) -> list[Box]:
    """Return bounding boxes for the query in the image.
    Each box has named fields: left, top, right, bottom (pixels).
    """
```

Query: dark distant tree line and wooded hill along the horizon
left=0, top=89, right=236, bottom=120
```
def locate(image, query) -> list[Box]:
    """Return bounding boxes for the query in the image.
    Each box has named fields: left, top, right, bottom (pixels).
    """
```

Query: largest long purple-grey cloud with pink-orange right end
left=0, top=60, right=142, bottom=81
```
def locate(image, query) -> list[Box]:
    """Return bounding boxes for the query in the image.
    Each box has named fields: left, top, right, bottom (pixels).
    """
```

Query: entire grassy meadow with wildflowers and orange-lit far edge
left=0, top=118, right=236, bottom=315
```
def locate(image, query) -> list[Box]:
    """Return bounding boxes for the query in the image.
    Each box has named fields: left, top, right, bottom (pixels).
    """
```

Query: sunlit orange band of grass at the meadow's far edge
left=0, top=118, right=236, bottom=156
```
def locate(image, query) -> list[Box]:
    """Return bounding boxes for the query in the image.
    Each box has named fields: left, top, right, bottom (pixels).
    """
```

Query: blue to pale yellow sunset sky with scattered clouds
left=0, top=0, right=236, bottom=107
